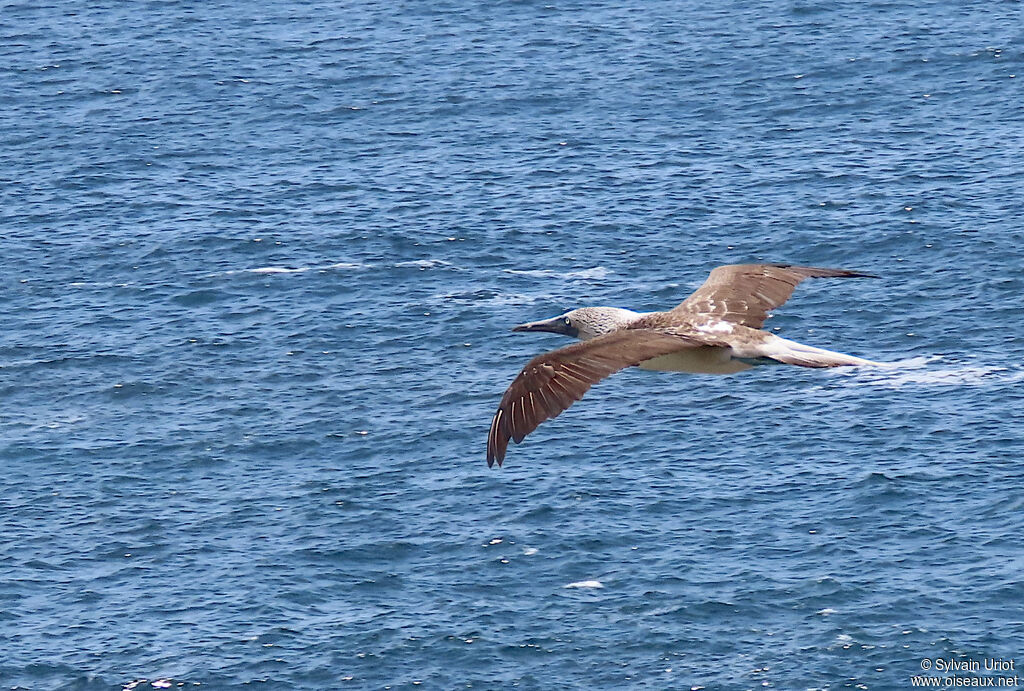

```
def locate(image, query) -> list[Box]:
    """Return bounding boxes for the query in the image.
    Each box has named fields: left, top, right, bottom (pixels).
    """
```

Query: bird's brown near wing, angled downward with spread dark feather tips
left=487, top=329, right=699, bottom=468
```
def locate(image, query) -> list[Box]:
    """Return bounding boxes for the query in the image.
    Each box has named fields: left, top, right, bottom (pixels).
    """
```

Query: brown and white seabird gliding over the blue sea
left=487, top=264, right=880, bottom=468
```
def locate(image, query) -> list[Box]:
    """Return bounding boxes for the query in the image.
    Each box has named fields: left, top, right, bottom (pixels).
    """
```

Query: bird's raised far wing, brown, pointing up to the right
left=670, top=264, right=876, bottom=329
